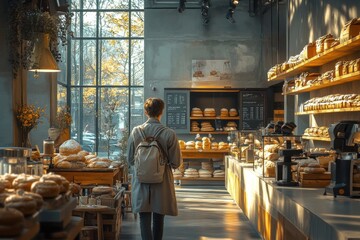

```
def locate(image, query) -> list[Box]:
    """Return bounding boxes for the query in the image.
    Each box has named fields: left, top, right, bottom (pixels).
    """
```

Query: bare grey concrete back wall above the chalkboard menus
left=145, top=1, right=266, bottom=98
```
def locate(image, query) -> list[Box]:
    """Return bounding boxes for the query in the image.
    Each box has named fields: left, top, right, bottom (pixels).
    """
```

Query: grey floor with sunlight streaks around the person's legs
left=121, top=186, right=261, bottom=240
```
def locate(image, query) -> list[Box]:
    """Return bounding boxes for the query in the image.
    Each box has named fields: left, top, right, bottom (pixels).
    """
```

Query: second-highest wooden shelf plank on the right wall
left=285, top=71, right=360, bottom=95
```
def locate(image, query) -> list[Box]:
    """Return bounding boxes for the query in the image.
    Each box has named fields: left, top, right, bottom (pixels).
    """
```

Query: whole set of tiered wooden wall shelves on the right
left=268, top=32, right=360, bottom=150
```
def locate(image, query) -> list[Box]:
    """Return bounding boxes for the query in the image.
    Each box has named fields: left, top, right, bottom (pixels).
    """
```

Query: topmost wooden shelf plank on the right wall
left=268, top=35, right=360, bottom=81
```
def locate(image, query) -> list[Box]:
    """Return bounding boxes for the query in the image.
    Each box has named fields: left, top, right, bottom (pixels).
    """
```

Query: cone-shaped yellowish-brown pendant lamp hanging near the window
left=29, top=33, right=60, bottom=74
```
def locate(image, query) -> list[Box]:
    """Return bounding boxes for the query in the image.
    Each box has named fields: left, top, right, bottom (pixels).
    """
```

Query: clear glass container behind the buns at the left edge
left=0, top=147, right=31, bottom=175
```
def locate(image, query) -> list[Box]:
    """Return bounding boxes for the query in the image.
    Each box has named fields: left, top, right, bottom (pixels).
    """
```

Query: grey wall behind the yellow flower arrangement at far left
left=0, top=1, right=54, bottom=150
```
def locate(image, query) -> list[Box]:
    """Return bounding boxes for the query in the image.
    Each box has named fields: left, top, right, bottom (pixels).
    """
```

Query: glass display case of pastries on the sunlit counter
left=254, top=134, right=303, bottom=178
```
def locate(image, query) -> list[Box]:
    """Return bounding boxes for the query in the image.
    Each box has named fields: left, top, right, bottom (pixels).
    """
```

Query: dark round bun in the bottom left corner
left=0, top=208, right=24, bottom=238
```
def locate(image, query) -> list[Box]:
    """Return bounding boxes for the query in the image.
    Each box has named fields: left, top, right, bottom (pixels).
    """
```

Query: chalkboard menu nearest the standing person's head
left=165, top=90, right=189, bottom=133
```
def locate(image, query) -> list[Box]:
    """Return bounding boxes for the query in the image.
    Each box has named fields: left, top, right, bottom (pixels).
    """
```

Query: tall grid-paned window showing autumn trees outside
left=58, top=0, right=144, bottom=158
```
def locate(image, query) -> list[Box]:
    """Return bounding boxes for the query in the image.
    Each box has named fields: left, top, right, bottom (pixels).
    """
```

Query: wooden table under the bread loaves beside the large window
left=48, top=167, right=123, bottom=186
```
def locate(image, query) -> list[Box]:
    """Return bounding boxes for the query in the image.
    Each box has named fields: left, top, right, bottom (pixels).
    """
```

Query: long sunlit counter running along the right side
left=225, top=156, right=360, bottom=240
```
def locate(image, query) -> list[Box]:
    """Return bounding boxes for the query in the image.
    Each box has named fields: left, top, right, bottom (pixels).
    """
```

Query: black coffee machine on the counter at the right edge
left=324, top=121, right=360, bottom=197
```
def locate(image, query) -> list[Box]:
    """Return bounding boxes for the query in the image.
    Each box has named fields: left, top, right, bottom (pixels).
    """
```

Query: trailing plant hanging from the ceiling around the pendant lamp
left=9, top=0, right=73, bottom=78
